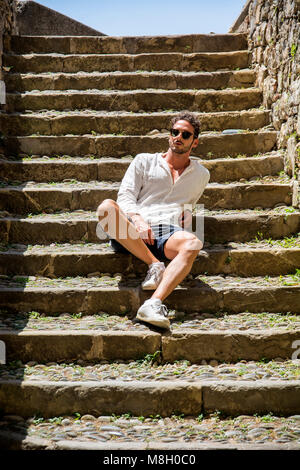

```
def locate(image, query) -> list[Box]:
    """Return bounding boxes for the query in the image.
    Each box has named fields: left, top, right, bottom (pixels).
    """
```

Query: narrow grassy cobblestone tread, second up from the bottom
left=0, top=360, right=300, bottom=382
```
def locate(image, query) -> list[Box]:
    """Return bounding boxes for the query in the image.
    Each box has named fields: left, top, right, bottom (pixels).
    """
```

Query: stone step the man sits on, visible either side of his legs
left=0, top=241, right=300, bottom=278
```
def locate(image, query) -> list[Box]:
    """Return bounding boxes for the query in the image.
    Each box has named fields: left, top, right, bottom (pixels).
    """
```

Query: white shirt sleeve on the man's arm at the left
left=117, top=154, right=144, bottom=214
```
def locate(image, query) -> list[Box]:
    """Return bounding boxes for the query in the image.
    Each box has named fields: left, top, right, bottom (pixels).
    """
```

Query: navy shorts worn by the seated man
left=110, top=224, right=184, bottom=261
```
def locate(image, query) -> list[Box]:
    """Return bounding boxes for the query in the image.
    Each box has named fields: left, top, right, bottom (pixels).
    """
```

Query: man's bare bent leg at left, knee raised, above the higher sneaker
left=97, top=199, right=159, bottom=266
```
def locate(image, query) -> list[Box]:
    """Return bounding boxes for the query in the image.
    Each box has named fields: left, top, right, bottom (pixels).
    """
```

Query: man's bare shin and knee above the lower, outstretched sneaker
left=151, top=231, right=203, bottom=301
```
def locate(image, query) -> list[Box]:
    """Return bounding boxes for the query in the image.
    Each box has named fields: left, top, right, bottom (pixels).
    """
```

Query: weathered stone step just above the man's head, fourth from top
left=6, top=88, right=262, bottom=112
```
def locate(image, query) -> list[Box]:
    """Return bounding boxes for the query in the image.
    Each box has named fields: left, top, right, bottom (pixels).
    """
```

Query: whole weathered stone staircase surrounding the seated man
left=0, top=34, right=300, bottom=449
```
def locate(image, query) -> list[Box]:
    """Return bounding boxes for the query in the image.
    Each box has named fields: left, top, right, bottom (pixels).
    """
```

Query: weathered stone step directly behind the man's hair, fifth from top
left=0, top=110, right=269, bottom=136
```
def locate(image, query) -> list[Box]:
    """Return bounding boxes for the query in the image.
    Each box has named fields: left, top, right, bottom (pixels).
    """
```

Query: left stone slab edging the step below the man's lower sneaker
left=0, top=329, right=161, bottom=363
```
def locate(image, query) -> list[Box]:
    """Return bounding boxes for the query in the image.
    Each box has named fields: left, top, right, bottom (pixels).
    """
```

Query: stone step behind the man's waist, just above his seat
left=0, top=207, right=300, bottom=244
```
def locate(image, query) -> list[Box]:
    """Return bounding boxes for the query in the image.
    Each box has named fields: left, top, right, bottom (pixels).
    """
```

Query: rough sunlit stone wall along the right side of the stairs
left=230, top=0, right=300, bottom=184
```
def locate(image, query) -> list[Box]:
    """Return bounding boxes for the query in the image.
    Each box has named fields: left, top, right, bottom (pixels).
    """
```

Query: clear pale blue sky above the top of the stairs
left=37, top=0, right=246, bottom=36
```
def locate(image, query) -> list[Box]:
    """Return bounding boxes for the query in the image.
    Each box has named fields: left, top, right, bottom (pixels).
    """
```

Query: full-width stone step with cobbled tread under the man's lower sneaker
left=0, top=312, right=300, bottom=362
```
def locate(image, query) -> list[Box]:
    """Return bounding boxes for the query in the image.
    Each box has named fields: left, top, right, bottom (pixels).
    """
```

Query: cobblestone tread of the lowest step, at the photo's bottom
left=0, top=411, right=300, bottom=448
